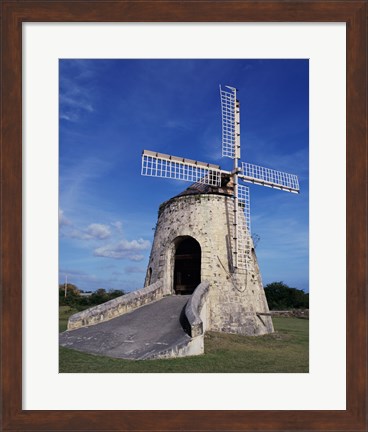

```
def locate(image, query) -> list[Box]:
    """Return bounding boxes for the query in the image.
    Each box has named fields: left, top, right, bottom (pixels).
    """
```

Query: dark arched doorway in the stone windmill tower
left=174, top=237, right=201, bottom=294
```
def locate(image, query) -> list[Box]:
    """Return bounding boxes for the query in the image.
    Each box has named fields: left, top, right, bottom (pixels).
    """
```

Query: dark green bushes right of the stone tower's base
left=264, top=282, right=309, bottom=310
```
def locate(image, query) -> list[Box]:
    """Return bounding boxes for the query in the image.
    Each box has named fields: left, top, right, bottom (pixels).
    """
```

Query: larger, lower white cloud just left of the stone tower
left=93, top=239, right=151, bottom=261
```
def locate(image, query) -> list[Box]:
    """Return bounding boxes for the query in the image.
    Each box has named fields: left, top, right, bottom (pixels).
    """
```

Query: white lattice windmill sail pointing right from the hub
left=239, top=162, right=299, bottom=193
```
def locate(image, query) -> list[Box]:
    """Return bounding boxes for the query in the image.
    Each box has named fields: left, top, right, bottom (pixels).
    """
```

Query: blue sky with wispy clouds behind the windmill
left=59, top=59, right=309, bottom=291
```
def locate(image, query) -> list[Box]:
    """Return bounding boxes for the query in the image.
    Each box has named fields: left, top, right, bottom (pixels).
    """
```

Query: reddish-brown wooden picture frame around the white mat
left=1, top=0, right=368, bottom=431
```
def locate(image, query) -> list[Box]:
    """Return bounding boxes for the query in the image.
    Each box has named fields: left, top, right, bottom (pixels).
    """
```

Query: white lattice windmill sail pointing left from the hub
left=141, top=150, right=221, bottom=186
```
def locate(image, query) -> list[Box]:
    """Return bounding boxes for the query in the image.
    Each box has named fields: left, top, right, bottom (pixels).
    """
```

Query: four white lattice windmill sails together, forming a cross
left=141, top=85, right=299, bottom=275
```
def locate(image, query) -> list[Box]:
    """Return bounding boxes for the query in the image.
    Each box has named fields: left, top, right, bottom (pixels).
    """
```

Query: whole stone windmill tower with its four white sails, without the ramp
left=142, top=86, right=299, bottom=335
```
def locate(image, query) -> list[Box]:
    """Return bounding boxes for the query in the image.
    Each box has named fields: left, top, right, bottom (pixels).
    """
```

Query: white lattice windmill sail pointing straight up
left=220, top=86, right=236, bottom=159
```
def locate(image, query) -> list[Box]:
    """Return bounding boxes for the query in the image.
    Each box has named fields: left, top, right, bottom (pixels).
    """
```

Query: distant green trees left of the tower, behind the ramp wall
left=59, top=284, right=125, bottom=311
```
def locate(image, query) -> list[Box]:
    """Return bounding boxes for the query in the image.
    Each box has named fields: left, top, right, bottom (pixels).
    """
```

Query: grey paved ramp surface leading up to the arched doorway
left=59, top=295, right=191, bottom=360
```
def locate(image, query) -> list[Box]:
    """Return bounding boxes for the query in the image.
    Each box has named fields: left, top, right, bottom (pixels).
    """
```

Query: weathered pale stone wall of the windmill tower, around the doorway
left=145, top=194, right=273, bottom=335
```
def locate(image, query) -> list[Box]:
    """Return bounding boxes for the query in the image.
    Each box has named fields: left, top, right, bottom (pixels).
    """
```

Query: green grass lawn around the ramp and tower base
left=59, top=307, right=309, bottom=373
